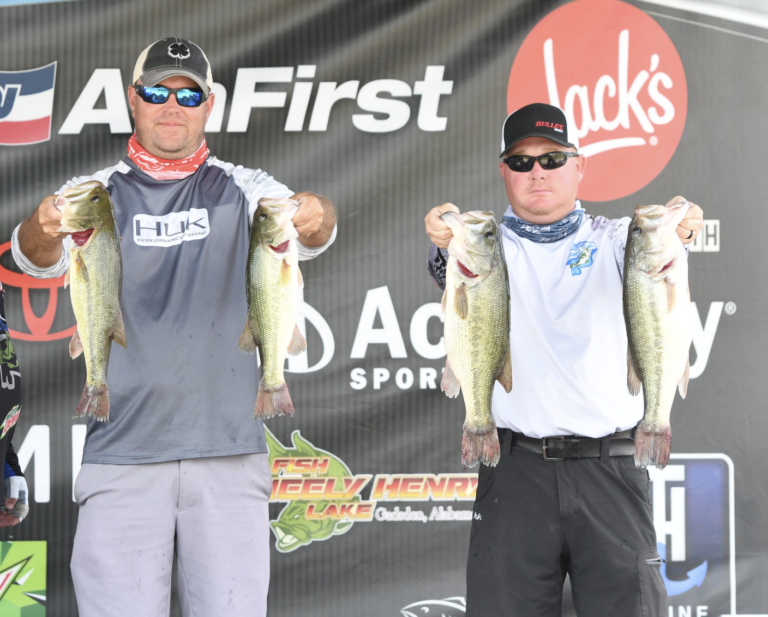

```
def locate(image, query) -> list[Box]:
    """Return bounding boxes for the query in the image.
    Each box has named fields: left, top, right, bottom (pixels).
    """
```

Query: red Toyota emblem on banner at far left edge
left=0, top=242, right=77, bottom=341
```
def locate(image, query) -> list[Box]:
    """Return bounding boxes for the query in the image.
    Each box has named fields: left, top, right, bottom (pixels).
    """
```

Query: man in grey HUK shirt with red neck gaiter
left=12, top=38, right=336, bottom=617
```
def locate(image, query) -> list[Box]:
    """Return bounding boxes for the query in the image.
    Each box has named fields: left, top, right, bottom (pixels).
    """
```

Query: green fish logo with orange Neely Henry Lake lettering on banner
left=264, top=427, right=477, bottom=553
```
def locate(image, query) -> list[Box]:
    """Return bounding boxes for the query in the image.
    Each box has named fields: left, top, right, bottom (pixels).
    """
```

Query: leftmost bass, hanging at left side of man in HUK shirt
left=55, top=181, right=126, bottom=422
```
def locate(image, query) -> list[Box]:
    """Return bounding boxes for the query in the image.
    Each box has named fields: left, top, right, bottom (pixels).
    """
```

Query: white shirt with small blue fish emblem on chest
left=493, top=208, right=643, bottom=438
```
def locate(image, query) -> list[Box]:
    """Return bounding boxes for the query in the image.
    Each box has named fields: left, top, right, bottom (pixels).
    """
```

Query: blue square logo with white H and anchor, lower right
left=649, top=454, right=736, bottom=615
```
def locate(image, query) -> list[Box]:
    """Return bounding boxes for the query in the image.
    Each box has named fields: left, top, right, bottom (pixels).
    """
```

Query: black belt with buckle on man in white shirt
left=498, top=428, right=635, bottom=461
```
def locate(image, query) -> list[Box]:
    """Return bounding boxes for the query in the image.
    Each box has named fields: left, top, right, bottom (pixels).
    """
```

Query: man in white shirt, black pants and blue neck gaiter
left=425, top=103, right=703, bottom=617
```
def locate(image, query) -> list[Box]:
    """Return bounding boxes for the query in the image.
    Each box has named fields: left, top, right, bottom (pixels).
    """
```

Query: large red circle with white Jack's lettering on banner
left=507, top=0, right=688, bottom=201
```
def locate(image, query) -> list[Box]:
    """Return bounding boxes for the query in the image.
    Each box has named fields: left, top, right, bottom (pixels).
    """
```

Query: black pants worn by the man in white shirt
left=467, top=448, right=666, bottom=617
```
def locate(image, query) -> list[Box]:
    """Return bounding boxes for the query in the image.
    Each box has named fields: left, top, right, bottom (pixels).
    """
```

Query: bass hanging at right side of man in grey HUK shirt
left=239, top=199, right=307, bottom=418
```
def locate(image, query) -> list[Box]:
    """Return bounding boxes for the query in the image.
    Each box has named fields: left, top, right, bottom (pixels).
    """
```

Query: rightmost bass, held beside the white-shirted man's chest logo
left=624, top=202, right=692, bottom=469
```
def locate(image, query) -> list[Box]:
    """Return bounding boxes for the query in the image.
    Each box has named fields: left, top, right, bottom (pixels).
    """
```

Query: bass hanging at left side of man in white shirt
left=440, top=211, right=512, bottom=467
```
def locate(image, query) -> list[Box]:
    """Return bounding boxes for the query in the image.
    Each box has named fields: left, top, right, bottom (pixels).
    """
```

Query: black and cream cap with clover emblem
left=133, top=36, right=213, bottom=96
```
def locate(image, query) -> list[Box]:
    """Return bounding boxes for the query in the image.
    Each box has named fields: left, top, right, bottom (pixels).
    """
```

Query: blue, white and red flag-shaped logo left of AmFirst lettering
left=0, top=62, right=56, bottom=146
